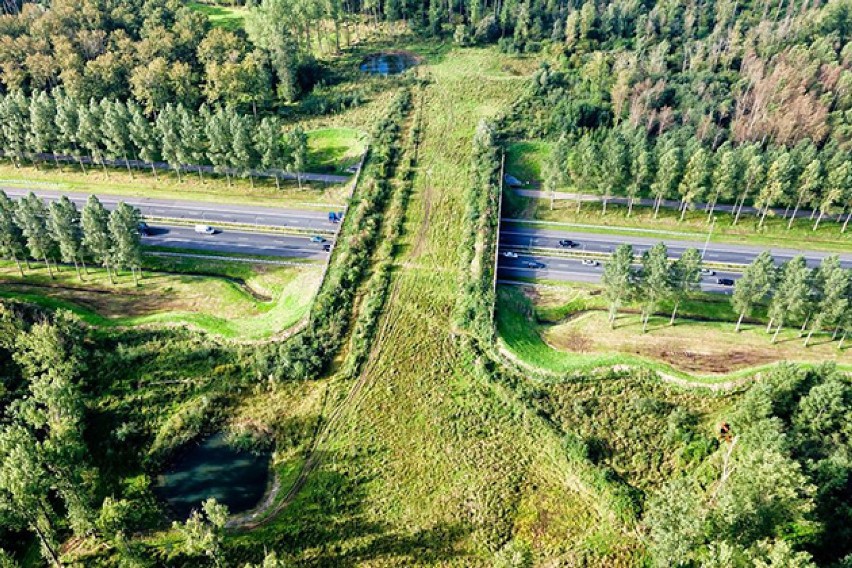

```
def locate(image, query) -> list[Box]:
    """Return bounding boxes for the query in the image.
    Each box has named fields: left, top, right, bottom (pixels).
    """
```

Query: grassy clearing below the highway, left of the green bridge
left=0, top=258, right=321, bottom=339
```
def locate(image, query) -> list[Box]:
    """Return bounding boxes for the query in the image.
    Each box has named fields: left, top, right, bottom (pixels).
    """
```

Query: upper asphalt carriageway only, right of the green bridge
left=500, top=221, right=852, bottom=269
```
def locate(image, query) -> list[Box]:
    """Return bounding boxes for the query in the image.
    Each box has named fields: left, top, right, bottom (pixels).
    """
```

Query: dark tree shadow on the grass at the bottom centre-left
left=228, top=456, right=472, bottom=567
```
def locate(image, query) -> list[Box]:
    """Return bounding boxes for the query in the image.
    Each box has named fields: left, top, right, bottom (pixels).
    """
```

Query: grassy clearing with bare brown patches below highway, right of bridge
left=497, top=286, right=852, bottom=382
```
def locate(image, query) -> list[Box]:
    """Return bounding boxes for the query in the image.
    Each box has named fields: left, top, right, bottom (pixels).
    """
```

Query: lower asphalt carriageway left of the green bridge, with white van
left=142, top=224, right=333, bottom=260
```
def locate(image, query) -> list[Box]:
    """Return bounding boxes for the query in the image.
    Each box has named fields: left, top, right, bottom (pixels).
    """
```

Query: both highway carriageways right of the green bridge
left=497, top=221, right=852, bottom=293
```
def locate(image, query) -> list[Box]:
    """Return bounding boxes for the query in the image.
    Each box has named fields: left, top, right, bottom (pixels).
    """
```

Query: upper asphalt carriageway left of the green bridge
left=0, top=187, right=340, bottom=231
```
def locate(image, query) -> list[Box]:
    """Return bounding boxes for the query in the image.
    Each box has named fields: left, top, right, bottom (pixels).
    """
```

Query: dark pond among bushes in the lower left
left=154, top=434, right=270, bottom=520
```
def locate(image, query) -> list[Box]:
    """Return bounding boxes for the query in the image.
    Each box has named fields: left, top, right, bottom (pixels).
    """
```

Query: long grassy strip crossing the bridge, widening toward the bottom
left=226, top=46, right=637, bottom=566
